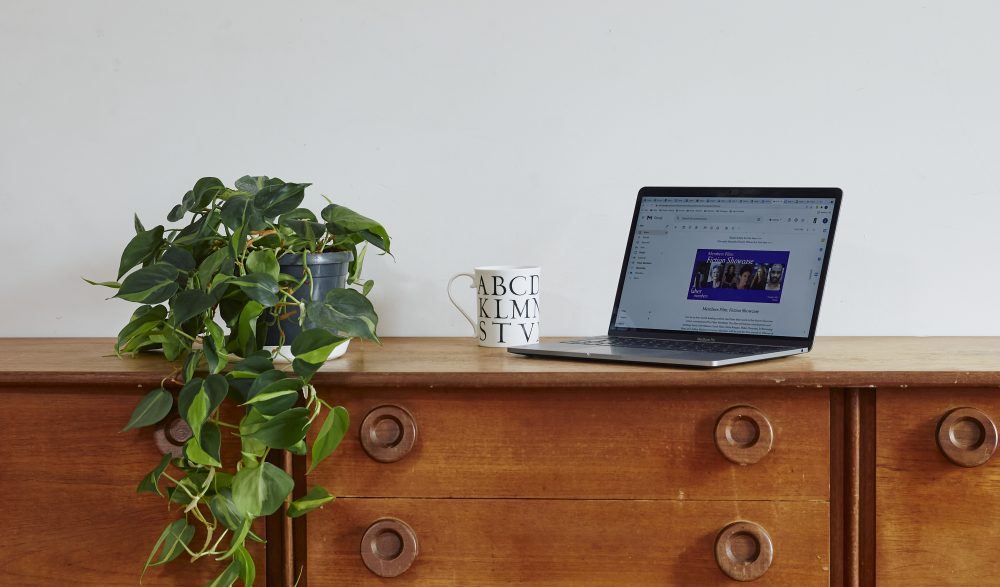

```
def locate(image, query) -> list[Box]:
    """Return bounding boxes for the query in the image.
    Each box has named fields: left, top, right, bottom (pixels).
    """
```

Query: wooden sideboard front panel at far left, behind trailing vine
left=0, top=385, right=265, bottom=587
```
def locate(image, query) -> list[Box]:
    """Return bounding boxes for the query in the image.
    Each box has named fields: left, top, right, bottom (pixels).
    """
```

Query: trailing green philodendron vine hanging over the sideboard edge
left=88, top=176, right=389, bottom=586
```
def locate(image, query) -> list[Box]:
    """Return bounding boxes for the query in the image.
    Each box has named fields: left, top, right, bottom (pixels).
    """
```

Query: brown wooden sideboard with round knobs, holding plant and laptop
left=0, top=337, right=1000, bottom=587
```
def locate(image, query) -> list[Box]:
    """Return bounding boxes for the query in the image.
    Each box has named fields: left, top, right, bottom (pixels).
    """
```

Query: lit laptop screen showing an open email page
left=612, top=188, right=838, bottom=338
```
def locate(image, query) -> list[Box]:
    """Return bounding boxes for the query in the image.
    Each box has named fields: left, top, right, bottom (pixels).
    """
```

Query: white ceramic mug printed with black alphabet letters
left=448, top=265, right=541, bottom=347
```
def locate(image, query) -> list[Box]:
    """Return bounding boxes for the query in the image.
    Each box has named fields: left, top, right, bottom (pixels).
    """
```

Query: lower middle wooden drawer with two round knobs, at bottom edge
left=308, top=499, right=829, bottom=587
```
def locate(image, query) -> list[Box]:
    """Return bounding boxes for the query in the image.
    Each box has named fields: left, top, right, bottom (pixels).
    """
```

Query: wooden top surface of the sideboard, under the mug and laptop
left=0, top=337, right=1000, bottom=389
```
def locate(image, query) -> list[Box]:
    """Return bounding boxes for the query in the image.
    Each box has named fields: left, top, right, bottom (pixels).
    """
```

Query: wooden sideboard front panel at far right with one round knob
left=875, top=388, right=1000, bottom=585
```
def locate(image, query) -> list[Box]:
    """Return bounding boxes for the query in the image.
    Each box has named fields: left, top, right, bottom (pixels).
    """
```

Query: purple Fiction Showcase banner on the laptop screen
left=688, top=249, right=788, bottom=304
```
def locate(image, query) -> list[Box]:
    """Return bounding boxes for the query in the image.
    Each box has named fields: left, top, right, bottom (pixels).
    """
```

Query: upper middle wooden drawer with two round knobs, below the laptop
left=313, top=388, right=830, bottom=500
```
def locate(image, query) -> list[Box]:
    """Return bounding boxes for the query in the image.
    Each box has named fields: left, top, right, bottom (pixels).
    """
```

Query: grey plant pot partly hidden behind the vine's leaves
left=264, top=251, right=354, bottom=346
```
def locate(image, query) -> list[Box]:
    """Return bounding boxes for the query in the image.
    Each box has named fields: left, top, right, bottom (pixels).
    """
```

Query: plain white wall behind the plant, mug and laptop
left=0, top=0, right=1000, bottom=336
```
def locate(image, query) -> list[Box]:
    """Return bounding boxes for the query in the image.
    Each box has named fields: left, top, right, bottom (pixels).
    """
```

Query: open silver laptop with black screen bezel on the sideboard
left=508, top=187, right=842, bottom=367
